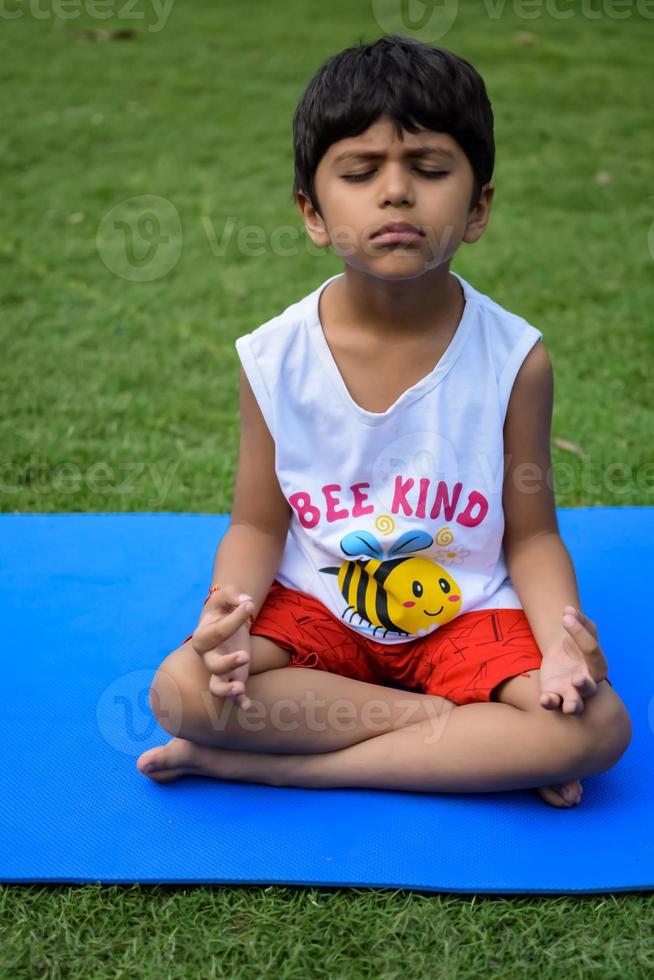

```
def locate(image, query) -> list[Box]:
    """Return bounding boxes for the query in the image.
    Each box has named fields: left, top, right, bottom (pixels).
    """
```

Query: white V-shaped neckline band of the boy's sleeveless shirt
left=307, top=270, right=477, bottom=425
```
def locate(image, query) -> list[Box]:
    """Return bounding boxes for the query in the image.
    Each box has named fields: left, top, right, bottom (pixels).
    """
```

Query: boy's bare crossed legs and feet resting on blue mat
left=137, top=637, right=631, bottom=806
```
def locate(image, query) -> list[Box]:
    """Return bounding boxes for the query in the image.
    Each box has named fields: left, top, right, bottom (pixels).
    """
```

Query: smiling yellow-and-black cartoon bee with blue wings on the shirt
left=320, top=531, right=462, bottom=637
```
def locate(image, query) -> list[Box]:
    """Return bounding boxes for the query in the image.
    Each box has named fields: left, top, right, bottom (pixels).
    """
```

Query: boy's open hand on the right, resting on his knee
left=540, top=606, right=608, bottom=715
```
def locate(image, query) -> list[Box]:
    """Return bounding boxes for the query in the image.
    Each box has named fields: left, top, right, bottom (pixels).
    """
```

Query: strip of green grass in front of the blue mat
left=0, top=885, right=654, bottom=980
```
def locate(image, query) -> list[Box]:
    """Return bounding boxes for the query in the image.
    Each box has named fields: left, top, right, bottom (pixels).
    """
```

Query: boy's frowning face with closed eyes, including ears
left=298, top=117, right=494, bottom=278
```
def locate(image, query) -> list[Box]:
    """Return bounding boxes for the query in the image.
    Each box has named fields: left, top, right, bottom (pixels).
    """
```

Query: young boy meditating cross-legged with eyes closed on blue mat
left=138, top=36, right=631, bottom=807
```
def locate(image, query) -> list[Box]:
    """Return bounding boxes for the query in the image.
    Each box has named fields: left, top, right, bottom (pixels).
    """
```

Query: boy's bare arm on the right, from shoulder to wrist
left=502, top=341, right=581, bottom=654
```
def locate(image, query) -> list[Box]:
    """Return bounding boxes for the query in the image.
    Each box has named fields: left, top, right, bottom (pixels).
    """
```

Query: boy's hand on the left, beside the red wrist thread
left=191, top=586, right=254, bottom=708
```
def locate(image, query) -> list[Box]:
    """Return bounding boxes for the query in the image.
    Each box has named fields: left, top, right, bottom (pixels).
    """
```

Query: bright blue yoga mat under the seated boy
left=0, top=507, right=654, bottom=893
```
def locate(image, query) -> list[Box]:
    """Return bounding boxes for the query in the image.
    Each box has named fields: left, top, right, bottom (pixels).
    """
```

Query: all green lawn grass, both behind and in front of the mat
left=0, top=0, right=654, bottom=980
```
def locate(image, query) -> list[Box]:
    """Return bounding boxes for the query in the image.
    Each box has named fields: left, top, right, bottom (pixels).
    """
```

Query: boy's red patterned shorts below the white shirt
left=233, top=580, right=543, bottom=704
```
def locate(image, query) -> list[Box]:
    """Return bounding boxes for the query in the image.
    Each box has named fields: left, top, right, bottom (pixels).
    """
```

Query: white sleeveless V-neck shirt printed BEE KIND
left=235, top=273, right=543, bottom=643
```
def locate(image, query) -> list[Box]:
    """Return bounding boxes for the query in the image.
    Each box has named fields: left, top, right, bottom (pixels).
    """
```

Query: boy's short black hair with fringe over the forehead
left=292, top=34, right=495, bottom=214
